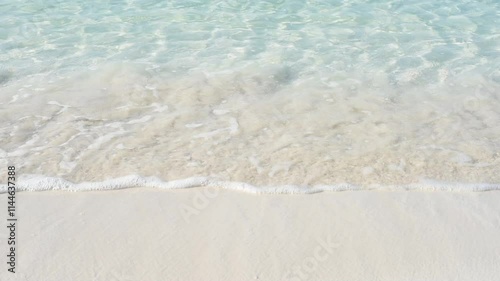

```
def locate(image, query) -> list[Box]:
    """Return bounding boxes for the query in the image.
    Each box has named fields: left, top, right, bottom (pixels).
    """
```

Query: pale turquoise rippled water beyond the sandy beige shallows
left=0, top=0, right=500, bottom=84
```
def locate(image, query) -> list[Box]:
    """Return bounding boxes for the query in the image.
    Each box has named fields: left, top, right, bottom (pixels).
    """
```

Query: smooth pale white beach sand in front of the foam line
left=0, top=189, right=500, bottom=281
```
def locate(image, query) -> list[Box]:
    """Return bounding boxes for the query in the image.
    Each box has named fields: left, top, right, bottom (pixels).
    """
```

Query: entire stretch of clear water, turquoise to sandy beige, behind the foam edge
left=0, top=0, right=500, bottom=190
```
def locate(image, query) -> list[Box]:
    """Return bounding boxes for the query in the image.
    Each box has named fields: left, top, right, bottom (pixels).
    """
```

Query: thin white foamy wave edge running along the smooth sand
left=0, top=175, right=500, bottom=194
